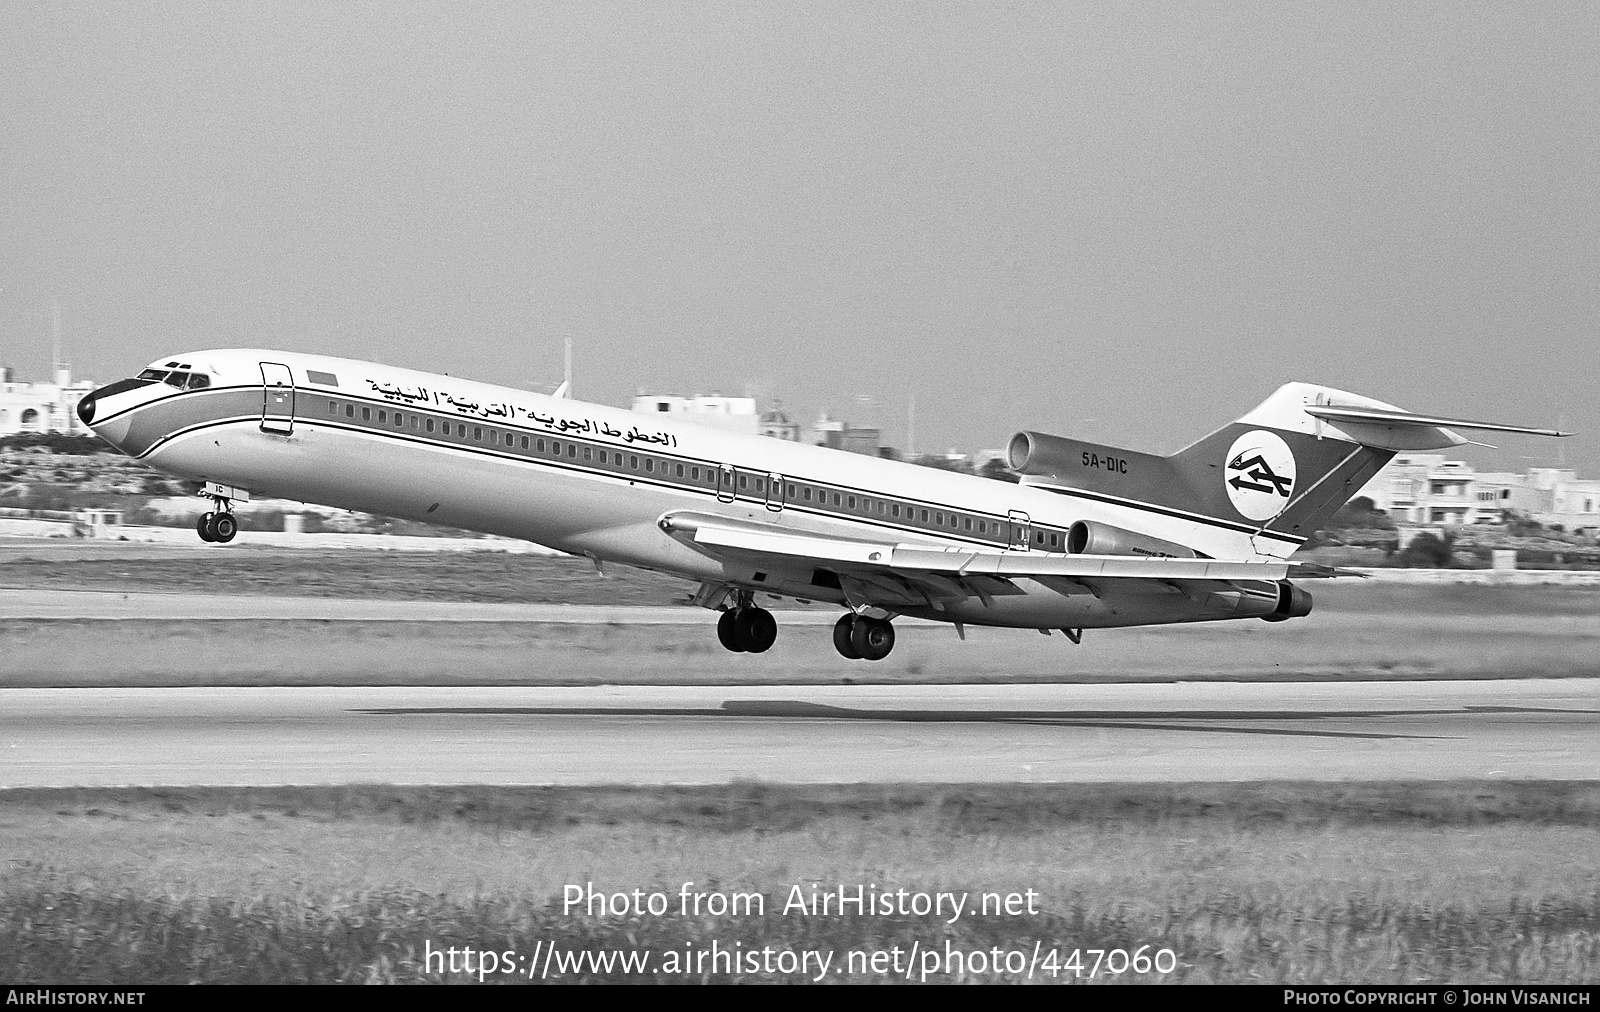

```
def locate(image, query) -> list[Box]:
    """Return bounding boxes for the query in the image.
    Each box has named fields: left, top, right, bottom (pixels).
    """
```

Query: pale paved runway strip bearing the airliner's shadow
left=0, top=679, right=1600, bottom=788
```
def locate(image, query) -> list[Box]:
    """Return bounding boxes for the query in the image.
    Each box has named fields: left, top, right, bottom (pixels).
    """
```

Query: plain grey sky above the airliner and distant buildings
left=0, top=0, right=1600, bottom=477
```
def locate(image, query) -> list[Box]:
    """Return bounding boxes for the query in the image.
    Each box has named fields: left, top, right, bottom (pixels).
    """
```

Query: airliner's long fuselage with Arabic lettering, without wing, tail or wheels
left=78, top=349, right=1302, bottom=640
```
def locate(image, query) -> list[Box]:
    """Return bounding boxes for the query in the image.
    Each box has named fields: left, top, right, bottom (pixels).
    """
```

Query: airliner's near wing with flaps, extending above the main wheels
left=659, top=512, right=1346, bottom=605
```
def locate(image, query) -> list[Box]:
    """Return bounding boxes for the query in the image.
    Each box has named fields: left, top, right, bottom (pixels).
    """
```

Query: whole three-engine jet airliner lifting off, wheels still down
left=78, top=349, right=1566, bottom=660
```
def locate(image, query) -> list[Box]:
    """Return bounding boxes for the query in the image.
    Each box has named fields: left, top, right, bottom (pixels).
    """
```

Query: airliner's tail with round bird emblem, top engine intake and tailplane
left=1010, top=383, right=1568, bottom=554
